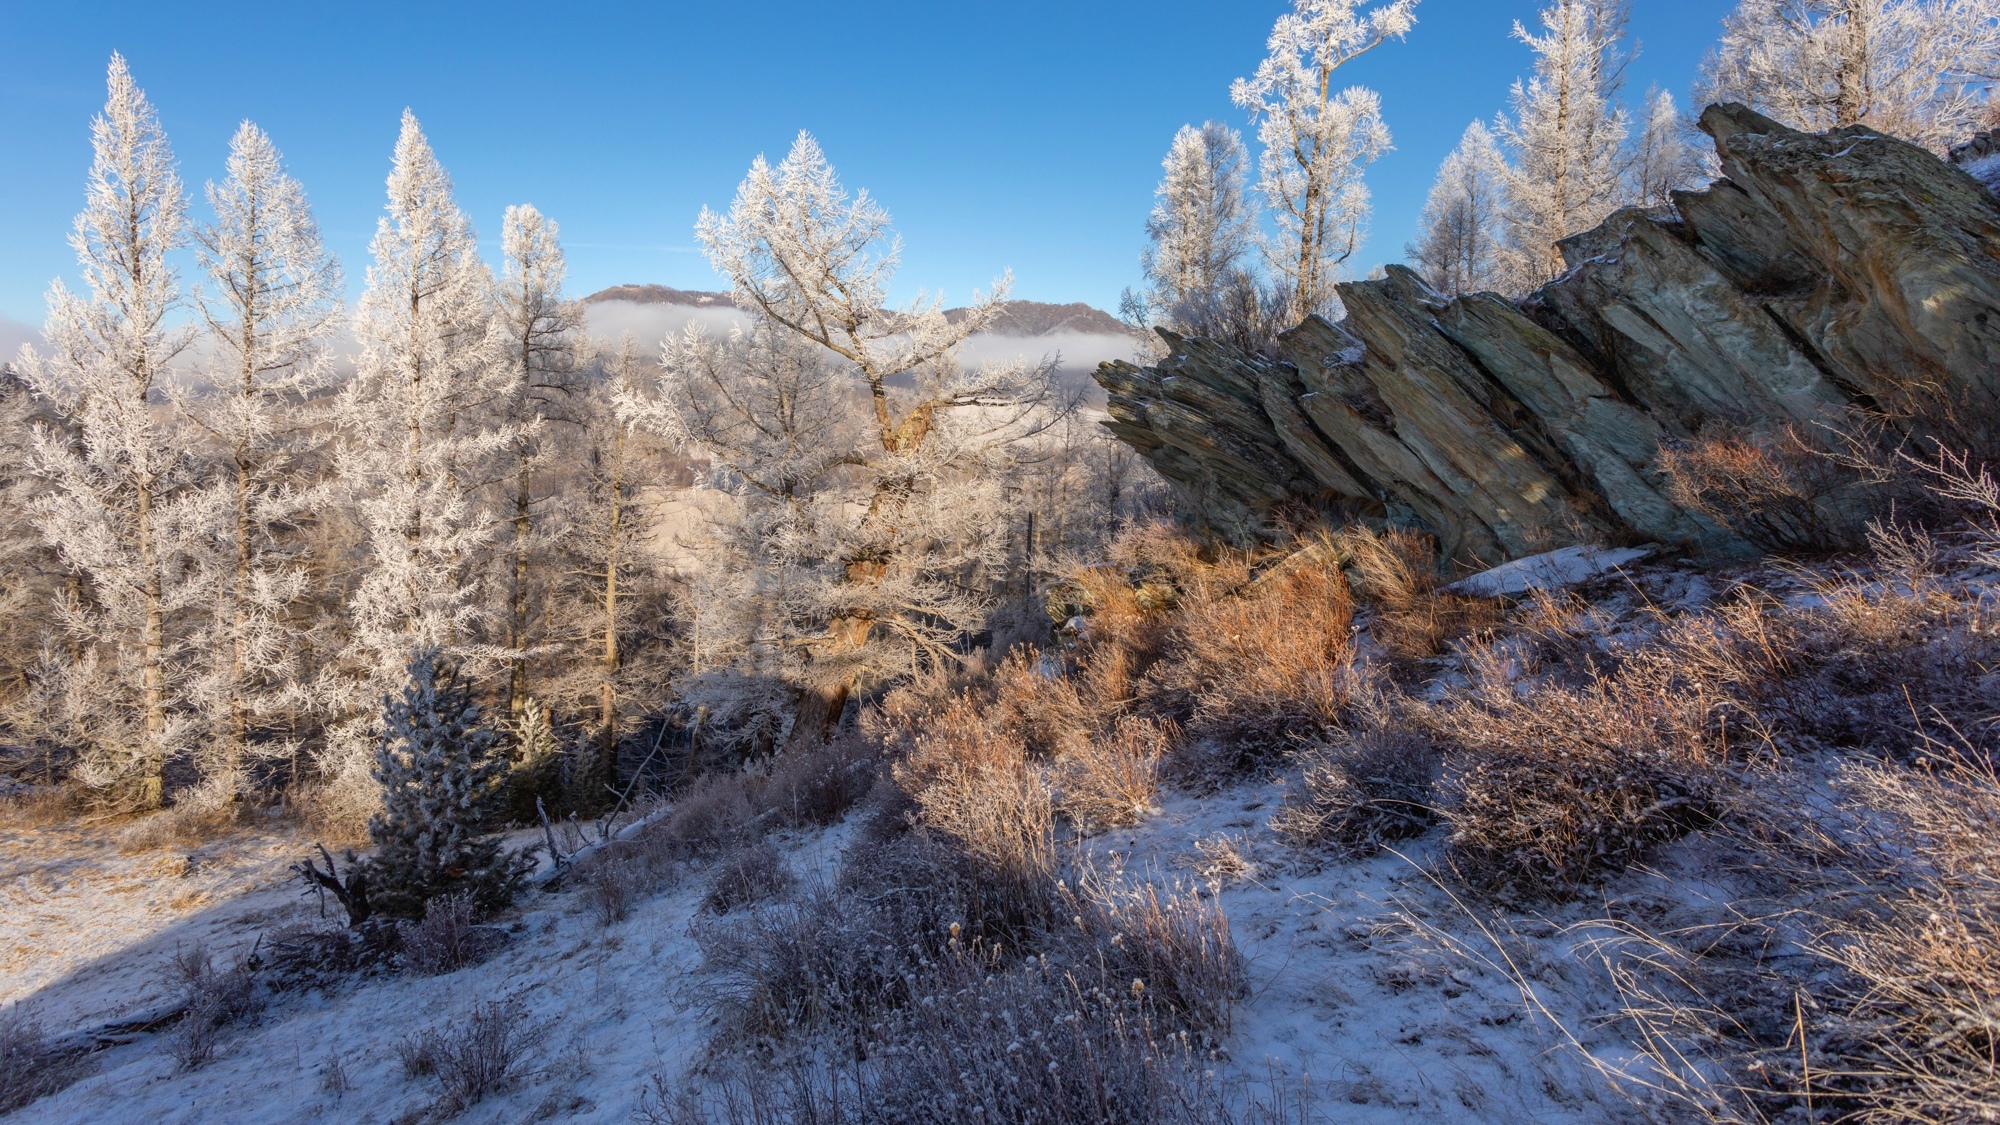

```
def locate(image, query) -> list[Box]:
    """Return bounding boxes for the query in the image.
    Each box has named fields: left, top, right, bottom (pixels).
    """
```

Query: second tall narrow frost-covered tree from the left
left=184, top=122, right=344, bottom=785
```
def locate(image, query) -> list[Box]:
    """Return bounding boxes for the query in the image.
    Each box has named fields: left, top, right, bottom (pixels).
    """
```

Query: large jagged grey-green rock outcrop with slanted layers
left=1096, top=106, right=2000, bottom=565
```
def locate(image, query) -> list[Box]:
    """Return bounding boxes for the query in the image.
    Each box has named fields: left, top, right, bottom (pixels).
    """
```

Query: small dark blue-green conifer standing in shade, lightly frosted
left=366, top=647, right=526, bottom=919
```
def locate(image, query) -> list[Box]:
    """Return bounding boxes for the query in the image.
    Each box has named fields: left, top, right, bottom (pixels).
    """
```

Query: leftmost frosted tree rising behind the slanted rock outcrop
left=1140, top=122, right=1256, bottom=332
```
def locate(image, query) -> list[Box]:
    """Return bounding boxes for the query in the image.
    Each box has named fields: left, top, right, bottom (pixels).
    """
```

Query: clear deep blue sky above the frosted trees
left=0, top=0, right=1734, bottom=324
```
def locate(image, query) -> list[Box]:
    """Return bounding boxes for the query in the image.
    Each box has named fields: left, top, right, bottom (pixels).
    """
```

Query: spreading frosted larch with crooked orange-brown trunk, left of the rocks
left=650, top=134, right=1056, bottom=737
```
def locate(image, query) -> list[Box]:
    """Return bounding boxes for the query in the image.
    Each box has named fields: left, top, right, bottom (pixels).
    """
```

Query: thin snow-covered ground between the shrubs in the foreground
left=0, top=768, right=1688, bottom=1125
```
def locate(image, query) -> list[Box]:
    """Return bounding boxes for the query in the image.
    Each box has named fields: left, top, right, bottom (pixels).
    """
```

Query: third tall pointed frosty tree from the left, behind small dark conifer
left=328, top=112, right=520, bottom=801
